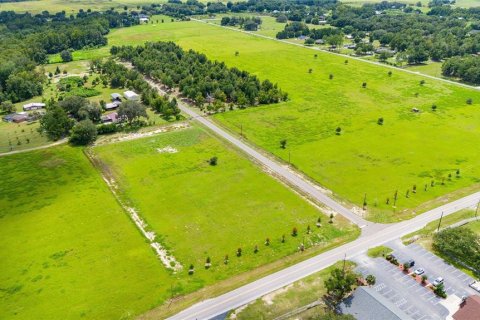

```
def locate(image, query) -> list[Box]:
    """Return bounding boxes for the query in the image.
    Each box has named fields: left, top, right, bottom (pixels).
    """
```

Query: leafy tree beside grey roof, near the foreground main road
left=325, top=268, right=356, bottom=307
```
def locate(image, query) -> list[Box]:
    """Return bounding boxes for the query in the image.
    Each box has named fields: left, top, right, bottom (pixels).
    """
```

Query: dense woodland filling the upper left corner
left=0, top=10, right=138, bottom=102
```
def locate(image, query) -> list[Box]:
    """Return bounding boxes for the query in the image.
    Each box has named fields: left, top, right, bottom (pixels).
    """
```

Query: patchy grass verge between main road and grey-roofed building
left=235, top=261, right=355, bottom=320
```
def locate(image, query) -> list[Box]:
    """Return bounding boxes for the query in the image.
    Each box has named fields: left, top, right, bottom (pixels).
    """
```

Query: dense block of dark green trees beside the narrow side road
left=111, top=42, right=288, bottom=109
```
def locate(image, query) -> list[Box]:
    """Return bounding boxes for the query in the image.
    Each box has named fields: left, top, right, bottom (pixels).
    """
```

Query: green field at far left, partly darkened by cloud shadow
left=0, top=146, right=173, bottom=319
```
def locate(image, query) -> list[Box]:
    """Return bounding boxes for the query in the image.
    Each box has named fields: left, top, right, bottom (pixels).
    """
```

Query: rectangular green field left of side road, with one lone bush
left=94, top=127, right=359, bottom=289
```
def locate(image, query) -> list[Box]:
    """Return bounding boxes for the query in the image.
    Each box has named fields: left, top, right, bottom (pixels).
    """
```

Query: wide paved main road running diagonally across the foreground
left=169, top=191, right=480, bottom=320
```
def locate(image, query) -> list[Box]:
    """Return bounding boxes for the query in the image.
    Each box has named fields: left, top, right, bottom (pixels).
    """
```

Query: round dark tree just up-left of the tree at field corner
left=39, top=105, right=73, bottom=140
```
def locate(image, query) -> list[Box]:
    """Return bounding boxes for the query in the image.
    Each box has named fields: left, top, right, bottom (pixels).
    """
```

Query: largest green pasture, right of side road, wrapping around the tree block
left=77, top=21, right=480, bottom=222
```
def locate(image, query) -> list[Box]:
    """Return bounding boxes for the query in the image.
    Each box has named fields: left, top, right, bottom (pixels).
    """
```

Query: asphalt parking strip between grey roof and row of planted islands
left=354, top=255, right=448, bottom=320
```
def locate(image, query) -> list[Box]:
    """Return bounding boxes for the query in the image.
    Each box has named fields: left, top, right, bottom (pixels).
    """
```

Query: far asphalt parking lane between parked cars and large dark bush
left=389, top=242, right=477, bottom=298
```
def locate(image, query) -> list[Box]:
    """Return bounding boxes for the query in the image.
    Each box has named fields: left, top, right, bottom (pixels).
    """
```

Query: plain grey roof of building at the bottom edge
left=339, top=287, right=411, bottom=320
